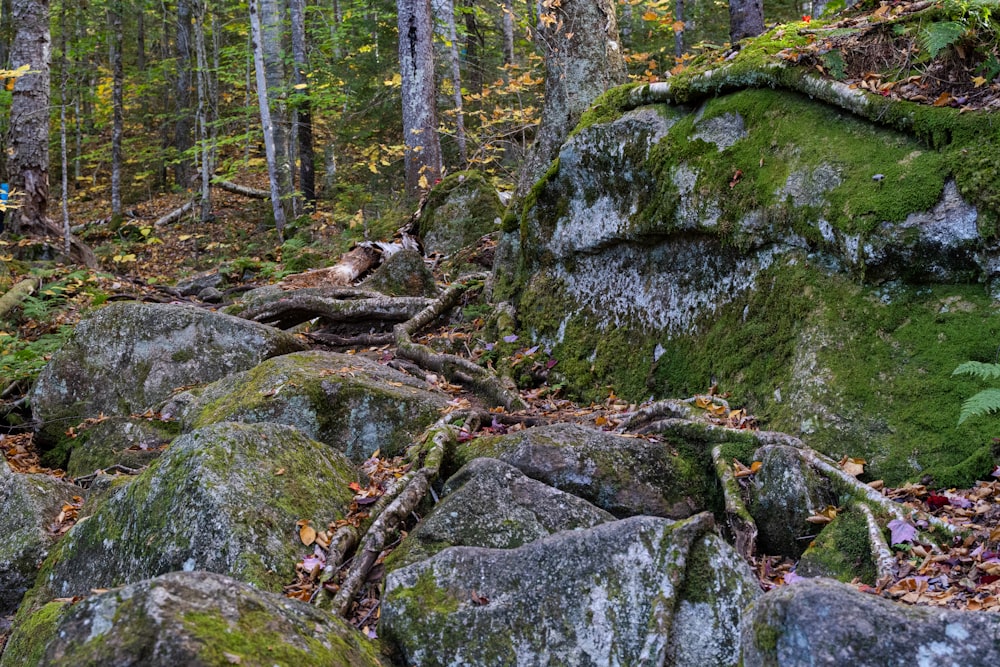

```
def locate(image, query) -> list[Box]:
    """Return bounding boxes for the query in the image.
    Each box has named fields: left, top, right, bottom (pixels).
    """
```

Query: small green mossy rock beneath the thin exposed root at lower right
left=798, top=511, right=875, bottom=585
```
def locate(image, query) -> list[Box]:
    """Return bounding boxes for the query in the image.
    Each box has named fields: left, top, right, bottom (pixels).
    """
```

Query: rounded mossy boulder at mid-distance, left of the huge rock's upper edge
left=417, top=171, right=503, bottom=255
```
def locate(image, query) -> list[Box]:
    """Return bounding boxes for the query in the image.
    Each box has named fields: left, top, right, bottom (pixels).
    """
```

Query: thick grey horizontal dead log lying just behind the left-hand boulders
left=240, top=292, right=431, bottom=332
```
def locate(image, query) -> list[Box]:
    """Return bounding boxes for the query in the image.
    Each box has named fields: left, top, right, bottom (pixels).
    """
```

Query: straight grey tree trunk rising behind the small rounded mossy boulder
left=397, top=0, right=441, bottom=199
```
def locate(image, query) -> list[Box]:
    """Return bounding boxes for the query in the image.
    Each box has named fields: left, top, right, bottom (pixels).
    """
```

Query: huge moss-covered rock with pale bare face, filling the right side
left=495, top=86, right=1000, bottom=486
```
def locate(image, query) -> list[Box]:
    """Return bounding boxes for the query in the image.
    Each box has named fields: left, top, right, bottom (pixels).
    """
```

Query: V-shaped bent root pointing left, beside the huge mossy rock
left=393, top=274, right=527, bottom=410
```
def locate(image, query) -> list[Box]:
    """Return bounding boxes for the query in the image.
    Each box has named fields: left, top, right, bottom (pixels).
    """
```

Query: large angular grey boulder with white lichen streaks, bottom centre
left=380, top=514, right=759, bottom=667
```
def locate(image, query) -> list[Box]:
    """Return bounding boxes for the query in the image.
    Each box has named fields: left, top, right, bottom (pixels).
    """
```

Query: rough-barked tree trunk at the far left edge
left=7, top=0, right=50, bottom=233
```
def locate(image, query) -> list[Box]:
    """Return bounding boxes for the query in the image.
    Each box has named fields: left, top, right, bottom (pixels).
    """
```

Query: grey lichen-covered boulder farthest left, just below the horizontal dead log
left=31, top=302, right=306, bottom=435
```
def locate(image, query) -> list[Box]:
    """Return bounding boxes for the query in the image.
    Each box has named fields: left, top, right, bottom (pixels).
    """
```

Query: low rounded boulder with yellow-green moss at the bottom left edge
left=31, top=572, right=382, bottom=667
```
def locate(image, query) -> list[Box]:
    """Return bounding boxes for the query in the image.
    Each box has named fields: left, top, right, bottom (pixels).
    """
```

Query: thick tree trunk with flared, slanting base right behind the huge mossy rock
left=515, top=0, right=626, bottom=197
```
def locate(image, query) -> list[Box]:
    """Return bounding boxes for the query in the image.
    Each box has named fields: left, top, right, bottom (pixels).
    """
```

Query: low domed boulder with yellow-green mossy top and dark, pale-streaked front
left=183, top=351, right=448, bottom=461
